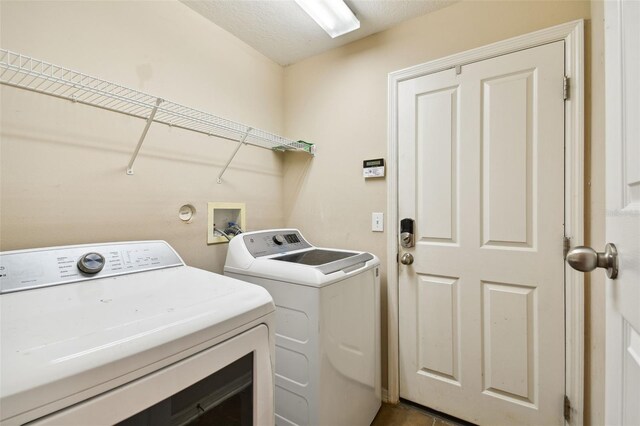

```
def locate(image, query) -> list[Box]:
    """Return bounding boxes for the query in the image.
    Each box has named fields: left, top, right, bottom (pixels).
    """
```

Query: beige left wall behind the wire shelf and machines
left=0, top=0, right=284, bottom=272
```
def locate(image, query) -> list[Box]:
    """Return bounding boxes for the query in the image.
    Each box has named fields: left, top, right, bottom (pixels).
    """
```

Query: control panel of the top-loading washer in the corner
left=242, top=229, right=311, bottom=257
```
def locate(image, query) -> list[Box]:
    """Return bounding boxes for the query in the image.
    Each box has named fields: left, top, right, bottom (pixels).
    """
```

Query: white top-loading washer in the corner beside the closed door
left=224, top=229, right=381, bottom=426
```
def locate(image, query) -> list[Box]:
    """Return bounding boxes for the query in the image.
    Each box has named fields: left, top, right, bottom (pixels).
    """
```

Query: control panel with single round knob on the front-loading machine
left=0, top=241, right=184, bottom=294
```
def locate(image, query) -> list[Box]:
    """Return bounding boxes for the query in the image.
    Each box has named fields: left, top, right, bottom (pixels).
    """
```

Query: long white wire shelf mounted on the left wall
left=0, top=49, right=315, bottom=155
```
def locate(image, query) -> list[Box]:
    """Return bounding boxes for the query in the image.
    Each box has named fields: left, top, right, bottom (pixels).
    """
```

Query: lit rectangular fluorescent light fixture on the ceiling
left=295, top=0, right=360, bottom=38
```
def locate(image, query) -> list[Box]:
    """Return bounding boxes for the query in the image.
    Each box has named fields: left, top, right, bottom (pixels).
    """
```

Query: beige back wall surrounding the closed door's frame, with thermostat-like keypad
left=284, top=1, right=604, bottom=424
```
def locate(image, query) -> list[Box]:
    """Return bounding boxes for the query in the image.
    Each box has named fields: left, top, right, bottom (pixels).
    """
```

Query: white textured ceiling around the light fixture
left=181, top=0, right=456, bottom=65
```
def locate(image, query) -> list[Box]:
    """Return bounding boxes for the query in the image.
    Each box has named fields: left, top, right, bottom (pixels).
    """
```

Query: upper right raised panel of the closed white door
left=480, top=70, right=537, bottom=249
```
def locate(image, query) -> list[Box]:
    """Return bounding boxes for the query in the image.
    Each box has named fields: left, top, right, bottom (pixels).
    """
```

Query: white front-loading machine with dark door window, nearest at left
left=0, top=241, right=275, bottom=426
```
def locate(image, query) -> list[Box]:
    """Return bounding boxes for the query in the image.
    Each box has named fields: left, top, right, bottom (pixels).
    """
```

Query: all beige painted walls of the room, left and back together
left=0, top=0, right=604, bottom=424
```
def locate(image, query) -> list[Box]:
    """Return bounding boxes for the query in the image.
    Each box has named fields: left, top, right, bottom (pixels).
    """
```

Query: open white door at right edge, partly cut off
left=604, top=1, right=640, bottom=425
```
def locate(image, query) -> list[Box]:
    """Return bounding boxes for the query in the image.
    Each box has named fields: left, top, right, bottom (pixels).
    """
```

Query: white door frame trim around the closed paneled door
left=384, top=20, right=584, bottom=425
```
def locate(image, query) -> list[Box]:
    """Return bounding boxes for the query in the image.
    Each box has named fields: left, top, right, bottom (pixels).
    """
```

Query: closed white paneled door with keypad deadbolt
left=398, top=42, right=565, bottom=425
